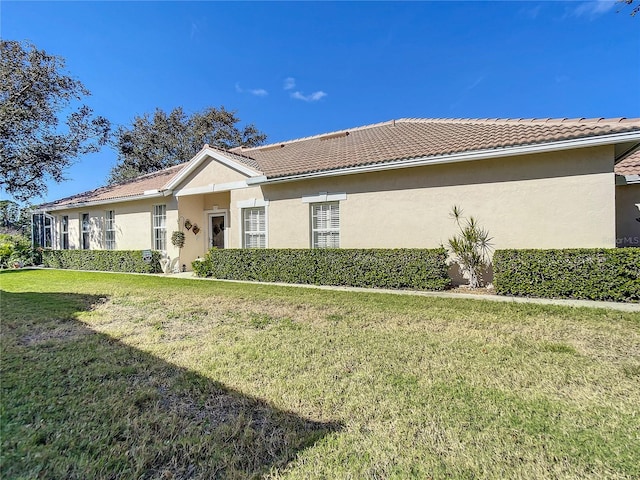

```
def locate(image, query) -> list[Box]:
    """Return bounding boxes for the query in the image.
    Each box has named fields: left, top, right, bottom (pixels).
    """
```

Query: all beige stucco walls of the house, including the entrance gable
left=46, top=147, right=620, bottom=276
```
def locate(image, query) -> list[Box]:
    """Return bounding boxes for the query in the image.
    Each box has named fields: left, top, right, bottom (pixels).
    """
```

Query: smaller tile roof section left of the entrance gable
left=39, top=163, right=186, bottom=209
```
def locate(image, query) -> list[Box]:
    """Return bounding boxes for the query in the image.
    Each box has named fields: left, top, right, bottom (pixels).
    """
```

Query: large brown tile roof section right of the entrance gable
left=232, top=118, right=640, bottom=178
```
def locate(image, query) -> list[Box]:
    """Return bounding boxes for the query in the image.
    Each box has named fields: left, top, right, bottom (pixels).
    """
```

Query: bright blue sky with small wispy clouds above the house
left=0, top=0, right=640, bottom=201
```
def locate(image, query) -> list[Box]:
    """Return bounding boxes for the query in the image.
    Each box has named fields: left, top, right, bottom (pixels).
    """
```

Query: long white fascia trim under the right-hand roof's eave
left=247, top=132, right=640, bottom=185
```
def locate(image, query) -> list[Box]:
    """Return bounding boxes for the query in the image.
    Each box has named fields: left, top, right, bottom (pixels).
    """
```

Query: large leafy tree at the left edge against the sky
left=0, top=40, right=110, bottom=201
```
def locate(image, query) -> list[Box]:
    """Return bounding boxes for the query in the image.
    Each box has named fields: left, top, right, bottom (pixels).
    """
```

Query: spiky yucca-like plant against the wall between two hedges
left=448, top=205, right=492, bottom=288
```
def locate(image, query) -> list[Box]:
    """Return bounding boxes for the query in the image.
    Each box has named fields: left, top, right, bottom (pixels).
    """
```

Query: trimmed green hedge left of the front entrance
left=42, top=250, right=162, bottom=273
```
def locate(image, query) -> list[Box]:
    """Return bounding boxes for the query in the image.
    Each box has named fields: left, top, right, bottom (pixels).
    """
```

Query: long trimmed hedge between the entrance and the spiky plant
left=192, top=248, right=451, bottom=290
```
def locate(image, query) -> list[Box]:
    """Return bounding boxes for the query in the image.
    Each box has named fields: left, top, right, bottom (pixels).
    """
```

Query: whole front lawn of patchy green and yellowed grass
left=0, top=271, right=640, bottom=479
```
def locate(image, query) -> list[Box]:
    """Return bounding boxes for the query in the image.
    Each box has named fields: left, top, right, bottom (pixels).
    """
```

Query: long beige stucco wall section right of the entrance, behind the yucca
left=263, top=147, right=615, bottom=248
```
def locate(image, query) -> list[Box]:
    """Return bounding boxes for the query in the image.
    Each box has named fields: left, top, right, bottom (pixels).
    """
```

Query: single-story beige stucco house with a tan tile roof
left=39, top=118, right=640, bottom=276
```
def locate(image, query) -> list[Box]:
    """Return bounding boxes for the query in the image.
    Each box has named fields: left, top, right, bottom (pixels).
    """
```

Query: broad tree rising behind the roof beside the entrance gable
left=108, top=107, right=267, bottom=184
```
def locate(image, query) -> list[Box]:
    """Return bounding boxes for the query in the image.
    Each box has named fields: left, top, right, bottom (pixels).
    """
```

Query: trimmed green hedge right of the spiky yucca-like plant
left=493, top=248, right=640, bottom=302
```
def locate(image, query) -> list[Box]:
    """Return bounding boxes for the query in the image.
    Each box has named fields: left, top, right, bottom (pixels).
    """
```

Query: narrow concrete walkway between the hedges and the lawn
left=158, top=272, right=640, bottom=313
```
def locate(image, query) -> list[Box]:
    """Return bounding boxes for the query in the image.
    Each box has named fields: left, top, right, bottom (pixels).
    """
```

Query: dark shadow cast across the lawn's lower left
left=0, top=291, right=341, bottom=479
